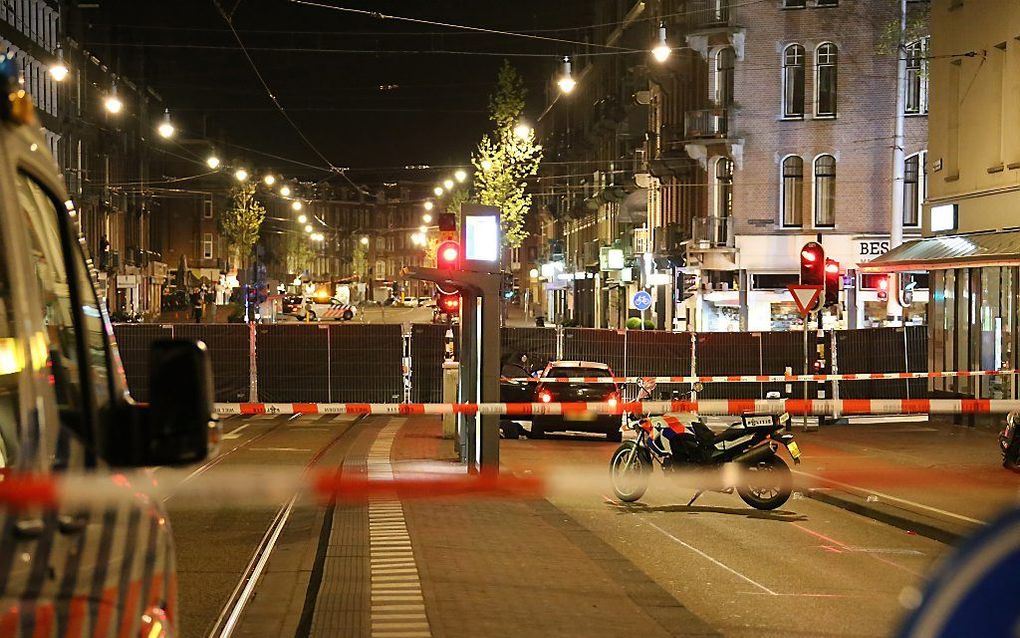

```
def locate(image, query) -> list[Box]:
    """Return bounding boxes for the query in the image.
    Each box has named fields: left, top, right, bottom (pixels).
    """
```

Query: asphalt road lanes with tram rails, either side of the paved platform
left=167, top=415, right=949, bottom=636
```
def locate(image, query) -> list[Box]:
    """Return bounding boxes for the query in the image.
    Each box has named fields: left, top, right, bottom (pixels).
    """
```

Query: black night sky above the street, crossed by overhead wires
left=83, top=0, right=592, bottom=183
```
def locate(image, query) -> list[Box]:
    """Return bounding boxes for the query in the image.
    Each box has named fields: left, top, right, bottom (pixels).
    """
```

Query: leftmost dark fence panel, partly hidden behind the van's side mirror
left=173, top=324, right=251, bottom=402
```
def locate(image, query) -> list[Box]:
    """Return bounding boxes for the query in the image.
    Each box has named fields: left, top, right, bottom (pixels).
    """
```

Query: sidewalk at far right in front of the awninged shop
left=795, top=422, right=1020, bottom=543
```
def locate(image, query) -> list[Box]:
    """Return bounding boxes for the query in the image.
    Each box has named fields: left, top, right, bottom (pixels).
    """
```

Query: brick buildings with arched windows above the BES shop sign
left=540, top=0, right=927, bottom=330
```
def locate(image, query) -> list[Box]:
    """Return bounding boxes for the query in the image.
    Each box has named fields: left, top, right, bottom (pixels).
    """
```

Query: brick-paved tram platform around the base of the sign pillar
left=394, top=418, right=716, bottom=637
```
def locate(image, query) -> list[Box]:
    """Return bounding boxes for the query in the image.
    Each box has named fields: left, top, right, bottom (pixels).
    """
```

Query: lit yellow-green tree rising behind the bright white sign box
left=471, top=62, right=542, bottom=248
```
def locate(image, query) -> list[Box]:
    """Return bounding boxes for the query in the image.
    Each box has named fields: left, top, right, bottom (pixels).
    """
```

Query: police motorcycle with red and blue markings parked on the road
left=609, top=384, right=801, bottom=509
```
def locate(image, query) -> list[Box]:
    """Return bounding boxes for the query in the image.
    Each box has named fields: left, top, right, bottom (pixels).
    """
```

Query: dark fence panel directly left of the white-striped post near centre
left=329, top=324, right=401, bottom=403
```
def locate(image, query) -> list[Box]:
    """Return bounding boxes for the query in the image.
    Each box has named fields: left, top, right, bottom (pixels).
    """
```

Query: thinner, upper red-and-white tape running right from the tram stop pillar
left=503, top=369, right=1020, bottom=383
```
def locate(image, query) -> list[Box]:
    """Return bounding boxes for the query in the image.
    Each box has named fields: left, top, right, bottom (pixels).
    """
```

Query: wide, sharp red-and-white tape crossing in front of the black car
left=215, top=399, right=1020, bottom=418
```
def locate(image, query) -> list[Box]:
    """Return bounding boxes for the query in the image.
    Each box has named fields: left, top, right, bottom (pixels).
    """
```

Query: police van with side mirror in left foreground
left=0, top=56, right=217, bottom=637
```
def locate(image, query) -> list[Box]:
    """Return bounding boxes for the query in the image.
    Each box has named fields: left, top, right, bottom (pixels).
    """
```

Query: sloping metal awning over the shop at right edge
left=858, top=231, right=1020, bottom=273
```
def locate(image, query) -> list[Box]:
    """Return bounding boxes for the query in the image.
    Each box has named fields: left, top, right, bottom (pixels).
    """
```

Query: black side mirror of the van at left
left=105, top=339, right=219, bottom=468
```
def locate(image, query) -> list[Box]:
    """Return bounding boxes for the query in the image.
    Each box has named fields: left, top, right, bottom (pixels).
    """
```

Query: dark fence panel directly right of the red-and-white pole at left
left=255, top=324, right=326, bottom=403
